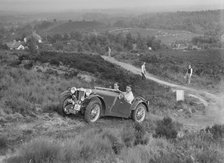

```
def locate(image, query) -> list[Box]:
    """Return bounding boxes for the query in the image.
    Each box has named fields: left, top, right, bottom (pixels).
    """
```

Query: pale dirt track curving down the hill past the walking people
left=102, top=56, right=224, bottom=128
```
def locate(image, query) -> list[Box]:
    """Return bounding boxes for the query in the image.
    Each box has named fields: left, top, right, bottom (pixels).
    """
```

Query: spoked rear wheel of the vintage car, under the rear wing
left=132, top=103, right=146, bottom=123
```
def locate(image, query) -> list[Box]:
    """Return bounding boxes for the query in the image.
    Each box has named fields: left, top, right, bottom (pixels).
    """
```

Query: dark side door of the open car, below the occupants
left=111, top=96, right=131, bottom=118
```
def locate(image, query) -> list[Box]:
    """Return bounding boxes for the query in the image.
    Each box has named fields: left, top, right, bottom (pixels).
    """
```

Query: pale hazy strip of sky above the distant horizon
left=0, top=0, right=224, bottom=12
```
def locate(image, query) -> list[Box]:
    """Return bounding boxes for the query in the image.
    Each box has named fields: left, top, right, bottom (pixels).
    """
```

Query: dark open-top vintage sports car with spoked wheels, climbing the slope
left=58, top=87, right=149, bottom=122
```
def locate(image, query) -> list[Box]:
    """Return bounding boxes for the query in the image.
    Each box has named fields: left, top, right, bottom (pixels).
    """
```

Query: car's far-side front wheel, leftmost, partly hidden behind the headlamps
left=58, top=93, right=72, bottom=116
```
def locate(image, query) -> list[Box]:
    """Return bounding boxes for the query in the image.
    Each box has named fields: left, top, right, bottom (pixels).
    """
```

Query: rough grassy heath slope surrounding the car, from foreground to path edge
left=0, top=51, right=224, bottom=163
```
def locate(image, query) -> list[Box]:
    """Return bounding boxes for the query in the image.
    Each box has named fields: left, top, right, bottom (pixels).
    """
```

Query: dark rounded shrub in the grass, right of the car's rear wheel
left=154, top=117, right=177, bottom=139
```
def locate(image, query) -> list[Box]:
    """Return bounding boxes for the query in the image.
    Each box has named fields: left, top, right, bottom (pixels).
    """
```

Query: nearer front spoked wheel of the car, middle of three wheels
left=84, top=98, right=102, bottom=123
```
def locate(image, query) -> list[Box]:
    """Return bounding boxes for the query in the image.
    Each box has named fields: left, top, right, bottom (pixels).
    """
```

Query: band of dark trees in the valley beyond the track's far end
left=44, top=32, right=165, bottom=54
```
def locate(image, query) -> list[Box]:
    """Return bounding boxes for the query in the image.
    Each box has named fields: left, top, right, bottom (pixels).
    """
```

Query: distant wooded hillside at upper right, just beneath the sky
left=115, top=10, right=224, bottom=35
